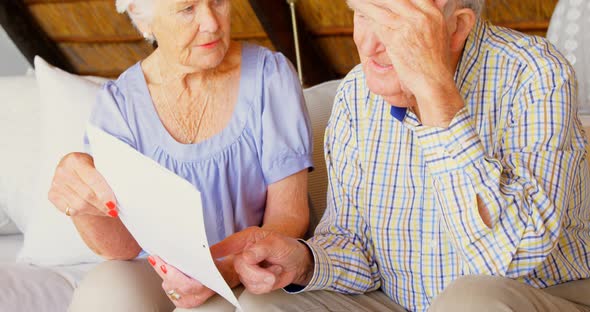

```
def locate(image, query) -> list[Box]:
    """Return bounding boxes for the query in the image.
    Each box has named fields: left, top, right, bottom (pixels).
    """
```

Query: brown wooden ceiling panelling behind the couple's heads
left=0, top=0, right=557, bottom=84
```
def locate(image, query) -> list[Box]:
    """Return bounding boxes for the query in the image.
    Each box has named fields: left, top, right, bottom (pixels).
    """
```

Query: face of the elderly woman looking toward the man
left=151, top=0, right=231, bottom=71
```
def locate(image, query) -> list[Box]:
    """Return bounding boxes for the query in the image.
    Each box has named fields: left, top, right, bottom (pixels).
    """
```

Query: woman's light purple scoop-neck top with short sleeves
left=86, top=44, right=313, bottom=245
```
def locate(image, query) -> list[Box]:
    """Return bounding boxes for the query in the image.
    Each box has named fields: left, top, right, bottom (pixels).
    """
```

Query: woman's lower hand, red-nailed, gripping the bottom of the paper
left=148, top=256, right=221, bottom=309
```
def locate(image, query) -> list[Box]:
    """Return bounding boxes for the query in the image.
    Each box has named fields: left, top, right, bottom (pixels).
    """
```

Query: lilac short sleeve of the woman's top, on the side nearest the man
left=259, top=53, right=313, bottom=184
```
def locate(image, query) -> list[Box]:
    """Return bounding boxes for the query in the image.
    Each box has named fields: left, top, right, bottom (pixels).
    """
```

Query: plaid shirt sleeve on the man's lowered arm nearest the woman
left=296, top=81, right=381, bottom=294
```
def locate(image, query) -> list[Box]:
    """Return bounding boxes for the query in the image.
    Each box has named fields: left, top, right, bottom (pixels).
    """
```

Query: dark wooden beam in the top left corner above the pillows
left=0, top=0, right=74, bottom=72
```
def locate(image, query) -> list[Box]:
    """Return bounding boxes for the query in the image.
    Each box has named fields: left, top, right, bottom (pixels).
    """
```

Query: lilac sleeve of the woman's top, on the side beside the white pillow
left=84, top=81, right=137, bottom=155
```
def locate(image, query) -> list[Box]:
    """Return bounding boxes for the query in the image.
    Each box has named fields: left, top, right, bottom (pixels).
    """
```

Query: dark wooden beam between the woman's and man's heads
left=248, top=0, right=338, bottom=86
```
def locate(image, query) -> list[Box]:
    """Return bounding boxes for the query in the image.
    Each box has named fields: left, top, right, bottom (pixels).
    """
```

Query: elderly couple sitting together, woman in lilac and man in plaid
left=49, top=0, right=590, bottom=311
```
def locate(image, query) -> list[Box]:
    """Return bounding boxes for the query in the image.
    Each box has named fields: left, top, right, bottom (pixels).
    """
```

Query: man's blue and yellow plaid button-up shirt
left=305, top=21, right=590, bottom=311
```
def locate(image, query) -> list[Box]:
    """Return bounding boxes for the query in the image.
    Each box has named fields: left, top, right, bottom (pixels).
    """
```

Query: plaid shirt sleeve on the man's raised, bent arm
left=416, top=62, right=588, bottom=278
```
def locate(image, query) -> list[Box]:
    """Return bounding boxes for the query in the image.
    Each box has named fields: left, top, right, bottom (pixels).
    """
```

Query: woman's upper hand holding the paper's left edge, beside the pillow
left=48, top=153, right=118, bottom=218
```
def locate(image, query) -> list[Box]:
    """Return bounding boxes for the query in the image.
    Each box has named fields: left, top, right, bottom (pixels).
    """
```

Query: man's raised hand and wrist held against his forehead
left=348, top=0, right=464, bottom=127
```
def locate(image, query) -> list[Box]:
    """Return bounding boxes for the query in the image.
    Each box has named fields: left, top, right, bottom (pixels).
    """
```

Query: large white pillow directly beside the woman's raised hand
left=18, top=57, right=106, bottom=265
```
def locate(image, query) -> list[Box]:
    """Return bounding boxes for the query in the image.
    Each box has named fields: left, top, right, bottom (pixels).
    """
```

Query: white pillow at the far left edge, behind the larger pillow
left=0, top=76, right=41, bottom=231
